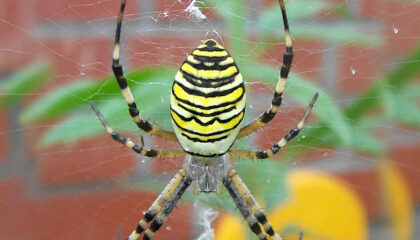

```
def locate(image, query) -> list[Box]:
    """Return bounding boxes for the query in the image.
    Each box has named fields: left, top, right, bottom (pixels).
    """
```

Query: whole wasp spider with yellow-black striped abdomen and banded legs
left=91, top=0, right=318, bottom=240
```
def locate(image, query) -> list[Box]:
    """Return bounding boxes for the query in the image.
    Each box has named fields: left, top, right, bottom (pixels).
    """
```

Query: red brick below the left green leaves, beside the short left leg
left=25, top=124, right=138, bottom=185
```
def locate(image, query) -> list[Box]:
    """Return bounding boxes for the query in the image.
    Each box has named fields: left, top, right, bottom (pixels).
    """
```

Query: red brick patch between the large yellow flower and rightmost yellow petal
left=336, top=166, right=382, bottom=219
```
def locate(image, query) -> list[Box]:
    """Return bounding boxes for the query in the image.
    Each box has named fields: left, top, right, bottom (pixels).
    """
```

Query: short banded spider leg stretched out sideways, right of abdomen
left=229, top=93, right=318, bottom=159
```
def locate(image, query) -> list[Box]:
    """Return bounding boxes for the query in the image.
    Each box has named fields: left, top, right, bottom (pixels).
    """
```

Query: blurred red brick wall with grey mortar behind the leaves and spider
left=0, top=0, right=420, bottom=239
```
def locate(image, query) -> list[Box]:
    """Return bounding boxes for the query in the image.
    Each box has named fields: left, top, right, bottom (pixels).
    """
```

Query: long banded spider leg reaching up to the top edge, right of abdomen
left=237, top=0, right=293, bottom=138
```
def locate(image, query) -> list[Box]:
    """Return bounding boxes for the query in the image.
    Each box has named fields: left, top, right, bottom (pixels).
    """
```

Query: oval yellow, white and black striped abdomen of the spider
left=171, top=39, right=245, bottom=157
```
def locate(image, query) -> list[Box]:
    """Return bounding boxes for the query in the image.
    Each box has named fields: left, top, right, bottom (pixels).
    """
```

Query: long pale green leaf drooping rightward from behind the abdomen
left=242, top=61, right=384, bottom=154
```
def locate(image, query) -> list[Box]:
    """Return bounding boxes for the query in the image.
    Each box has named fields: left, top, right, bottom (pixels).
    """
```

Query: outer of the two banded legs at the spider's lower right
left=225, top=168, right=281, bottom=240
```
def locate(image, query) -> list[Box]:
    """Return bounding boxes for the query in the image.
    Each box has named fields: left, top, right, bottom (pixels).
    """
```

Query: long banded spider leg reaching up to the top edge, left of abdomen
left=112, top=0, right=177, bottom=141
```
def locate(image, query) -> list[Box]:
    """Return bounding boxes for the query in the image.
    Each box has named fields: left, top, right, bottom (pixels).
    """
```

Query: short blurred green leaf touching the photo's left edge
left=0, top=61, right=50, bottom=110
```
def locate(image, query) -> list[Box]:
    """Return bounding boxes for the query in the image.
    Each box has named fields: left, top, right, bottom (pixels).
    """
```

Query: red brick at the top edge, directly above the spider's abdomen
left=153, top=0, right=218, bottom=22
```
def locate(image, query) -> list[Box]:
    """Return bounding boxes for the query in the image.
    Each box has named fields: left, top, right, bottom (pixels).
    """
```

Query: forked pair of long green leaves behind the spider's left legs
left=37, top=68, right=176, bottom=147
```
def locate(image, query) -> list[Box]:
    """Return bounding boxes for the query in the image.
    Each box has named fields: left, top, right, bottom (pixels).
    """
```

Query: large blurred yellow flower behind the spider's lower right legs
left=215, top=170, right=368, bottom=240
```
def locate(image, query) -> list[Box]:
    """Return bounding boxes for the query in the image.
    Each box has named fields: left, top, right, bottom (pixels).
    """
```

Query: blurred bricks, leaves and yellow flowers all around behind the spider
left=0, top=0, right=420, bottom=240
